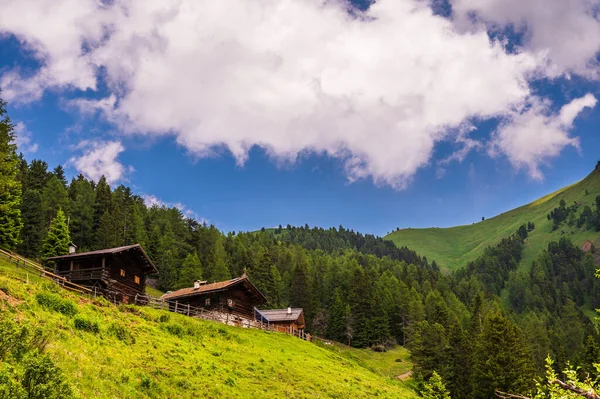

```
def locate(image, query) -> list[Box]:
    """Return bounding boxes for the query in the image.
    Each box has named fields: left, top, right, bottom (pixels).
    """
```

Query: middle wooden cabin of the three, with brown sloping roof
left=161, top=273, right=267, bottom=325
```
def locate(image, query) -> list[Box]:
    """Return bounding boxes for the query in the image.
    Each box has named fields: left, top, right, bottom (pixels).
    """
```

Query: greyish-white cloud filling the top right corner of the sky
left=451, top=0, right=600, bottom=79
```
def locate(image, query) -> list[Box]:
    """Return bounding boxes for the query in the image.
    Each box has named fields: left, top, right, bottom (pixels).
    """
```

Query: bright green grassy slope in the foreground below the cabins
left=0, top=258, right=417, bottom=398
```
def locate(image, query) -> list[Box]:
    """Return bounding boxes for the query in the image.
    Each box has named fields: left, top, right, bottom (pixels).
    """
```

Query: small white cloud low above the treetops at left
left=68, top=140, right=133, bottom=184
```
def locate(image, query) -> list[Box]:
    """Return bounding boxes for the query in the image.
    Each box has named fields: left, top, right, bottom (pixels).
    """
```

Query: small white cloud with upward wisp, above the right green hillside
left=490, top=94, right=597, bottom=179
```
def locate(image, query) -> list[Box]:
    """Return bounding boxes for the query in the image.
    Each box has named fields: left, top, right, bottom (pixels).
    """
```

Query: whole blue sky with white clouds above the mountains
left=0, top=0, right=600, bottom=235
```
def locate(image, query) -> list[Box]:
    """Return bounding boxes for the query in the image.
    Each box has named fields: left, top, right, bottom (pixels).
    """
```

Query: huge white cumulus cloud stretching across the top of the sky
left=0, top=0, right=596, bottom=188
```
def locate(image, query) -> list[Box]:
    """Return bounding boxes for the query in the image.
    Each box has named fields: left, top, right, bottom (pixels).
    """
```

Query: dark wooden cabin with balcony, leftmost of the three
left=48, top=244, right=157, bottom=303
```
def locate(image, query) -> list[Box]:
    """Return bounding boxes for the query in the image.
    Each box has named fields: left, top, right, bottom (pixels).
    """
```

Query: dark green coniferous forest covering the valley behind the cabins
left=0, top=92, right=600, bottom=398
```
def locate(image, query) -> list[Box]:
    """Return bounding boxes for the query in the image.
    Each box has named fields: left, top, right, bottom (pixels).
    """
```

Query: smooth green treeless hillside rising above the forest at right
left=385, top=166, right=600, bottom=271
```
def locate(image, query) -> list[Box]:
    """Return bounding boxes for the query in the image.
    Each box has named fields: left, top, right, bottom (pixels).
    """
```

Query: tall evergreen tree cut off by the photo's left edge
left=0, top=94, right=23, bottom=248
